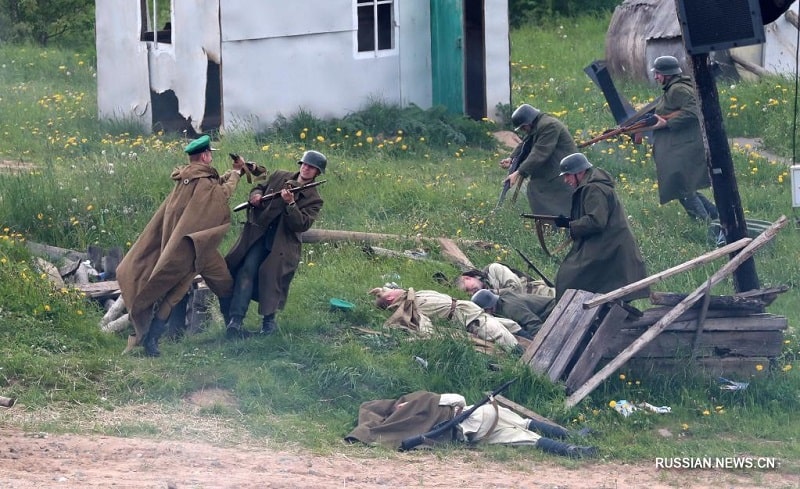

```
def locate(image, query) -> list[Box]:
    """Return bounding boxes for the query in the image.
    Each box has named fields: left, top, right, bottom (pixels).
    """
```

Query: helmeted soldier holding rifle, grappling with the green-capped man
left=220, top=151, right=328, bottom=337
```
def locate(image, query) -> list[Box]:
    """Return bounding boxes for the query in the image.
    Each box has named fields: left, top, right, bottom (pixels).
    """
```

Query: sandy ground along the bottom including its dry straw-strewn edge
left=0, top=389, right=800, bottom=489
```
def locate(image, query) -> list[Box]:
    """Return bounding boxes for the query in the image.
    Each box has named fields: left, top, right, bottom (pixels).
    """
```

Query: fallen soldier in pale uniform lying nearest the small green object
left=369, top=287, right=524, bottom=349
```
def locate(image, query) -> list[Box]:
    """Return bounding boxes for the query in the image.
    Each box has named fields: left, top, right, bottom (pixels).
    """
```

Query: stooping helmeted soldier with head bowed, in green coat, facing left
left=500, top=104, right=578, bottom=216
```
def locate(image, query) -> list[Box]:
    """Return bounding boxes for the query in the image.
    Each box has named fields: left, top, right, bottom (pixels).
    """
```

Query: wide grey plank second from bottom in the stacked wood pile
left=603, top=330, right=783, bottom=358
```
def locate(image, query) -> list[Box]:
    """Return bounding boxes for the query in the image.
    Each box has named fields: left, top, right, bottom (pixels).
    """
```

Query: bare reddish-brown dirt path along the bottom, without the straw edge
left=0, top=429, right=800, bottom=489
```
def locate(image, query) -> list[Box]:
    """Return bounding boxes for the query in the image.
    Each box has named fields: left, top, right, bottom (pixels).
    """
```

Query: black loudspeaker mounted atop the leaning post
left=678, top=0, right=765, bottom=55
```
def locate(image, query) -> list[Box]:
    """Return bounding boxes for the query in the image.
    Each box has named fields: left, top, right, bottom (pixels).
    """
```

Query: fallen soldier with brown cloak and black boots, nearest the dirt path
left=344, top=391, right=597, bottom=458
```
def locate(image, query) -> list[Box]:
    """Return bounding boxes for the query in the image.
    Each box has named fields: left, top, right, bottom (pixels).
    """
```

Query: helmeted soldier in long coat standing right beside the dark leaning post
left=642, top=56, right=719, bottom=220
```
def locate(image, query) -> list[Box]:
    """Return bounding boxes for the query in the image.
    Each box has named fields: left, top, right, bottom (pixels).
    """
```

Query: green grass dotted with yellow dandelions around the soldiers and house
left=0, top=13, right=800, bottom=470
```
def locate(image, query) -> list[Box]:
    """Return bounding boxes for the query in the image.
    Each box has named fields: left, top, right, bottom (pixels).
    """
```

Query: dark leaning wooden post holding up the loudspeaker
left=690, top=53, right=758, bottom=292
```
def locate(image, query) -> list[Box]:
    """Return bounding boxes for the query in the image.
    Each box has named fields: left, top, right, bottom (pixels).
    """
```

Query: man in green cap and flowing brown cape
left=117, top=136, right=245, bottom=357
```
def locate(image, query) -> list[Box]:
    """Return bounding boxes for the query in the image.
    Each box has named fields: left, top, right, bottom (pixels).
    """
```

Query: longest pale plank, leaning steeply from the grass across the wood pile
left=566, top=216, right=789, bottom=408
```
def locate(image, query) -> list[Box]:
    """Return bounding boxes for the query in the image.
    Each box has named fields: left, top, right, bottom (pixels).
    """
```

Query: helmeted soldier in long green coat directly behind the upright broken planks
left=556, top=153, right=649, bottom=301
